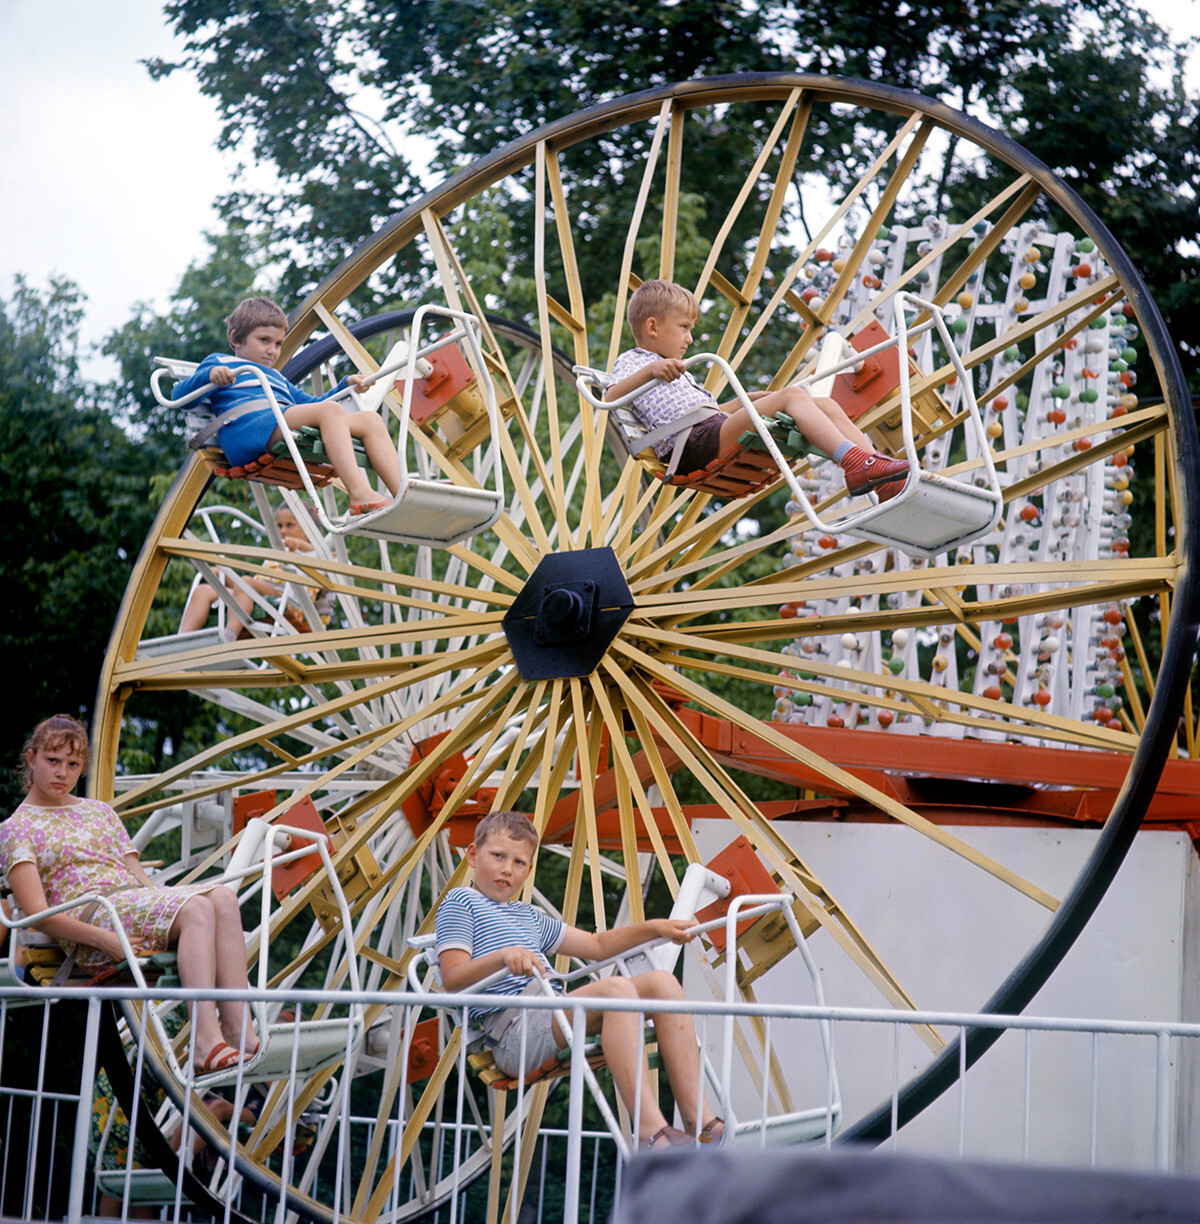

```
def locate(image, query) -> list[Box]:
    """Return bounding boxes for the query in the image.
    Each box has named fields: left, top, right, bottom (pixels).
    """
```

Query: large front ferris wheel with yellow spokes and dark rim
left=92, top=73, right=1198, bottom=1219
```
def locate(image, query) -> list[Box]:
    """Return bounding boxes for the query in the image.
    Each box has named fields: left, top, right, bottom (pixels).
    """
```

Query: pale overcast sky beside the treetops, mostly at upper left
left=0, top=0, right=1200, bottom=377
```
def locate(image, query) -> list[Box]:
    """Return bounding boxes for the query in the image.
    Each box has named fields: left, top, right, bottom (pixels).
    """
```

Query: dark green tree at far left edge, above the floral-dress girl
left=0, top=279, right=154, bottom=810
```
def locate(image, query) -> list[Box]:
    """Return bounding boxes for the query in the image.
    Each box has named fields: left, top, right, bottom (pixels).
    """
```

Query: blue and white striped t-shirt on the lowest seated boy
left=435, top=889, right=567, bottom=1020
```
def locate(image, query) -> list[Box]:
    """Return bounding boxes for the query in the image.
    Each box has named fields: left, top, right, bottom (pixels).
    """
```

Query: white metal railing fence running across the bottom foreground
left=0, top=987, right=1200, bottom=1224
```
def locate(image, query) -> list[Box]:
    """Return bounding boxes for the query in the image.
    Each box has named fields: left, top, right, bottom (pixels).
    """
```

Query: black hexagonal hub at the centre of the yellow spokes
left=503, top=548, right=633, bottom=681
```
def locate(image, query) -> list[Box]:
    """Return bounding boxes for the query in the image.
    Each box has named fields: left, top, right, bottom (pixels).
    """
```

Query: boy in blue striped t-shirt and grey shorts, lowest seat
left=437, top=812, right=725, bottom=1147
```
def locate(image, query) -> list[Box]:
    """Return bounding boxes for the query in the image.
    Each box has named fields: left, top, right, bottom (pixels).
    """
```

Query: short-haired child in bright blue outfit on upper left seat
left=174, top=297, right=400, bottom=514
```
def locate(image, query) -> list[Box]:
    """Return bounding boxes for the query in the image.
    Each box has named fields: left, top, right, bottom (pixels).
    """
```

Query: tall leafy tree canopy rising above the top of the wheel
left=151, top=0, right=1200, bottom=391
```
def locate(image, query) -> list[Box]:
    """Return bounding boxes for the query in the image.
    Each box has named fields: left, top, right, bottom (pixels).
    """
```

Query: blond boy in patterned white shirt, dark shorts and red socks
left=605, top=280, right=909, bottom=502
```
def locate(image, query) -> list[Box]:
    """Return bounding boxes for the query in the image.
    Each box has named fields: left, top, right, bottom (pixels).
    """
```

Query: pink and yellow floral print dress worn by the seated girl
left=0, top=799, right=214, bottom=972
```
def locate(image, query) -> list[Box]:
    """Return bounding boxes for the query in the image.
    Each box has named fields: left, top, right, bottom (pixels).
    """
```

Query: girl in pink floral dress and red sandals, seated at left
left=0, top=714, right=258, bottom=1073
